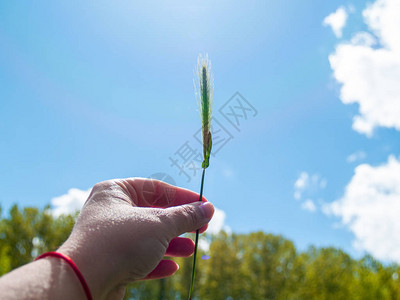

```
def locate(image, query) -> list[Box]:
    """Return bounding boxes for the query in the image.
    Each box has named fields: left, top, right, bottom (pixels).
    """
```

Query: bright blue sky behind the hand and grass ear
left=0, top=0, right=400, bottom=260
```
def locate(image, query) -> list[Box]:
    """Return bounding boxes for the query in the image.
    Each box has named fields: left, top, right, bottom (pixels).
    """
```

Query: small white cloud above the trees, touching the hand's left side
left=51, top=188, right=91, bottom=217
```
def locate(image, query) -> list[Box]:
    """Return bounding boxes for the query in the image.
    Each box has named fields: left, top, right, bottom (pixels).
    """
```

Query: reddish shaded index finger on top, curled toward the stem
left=119, top=178, right=207, bottom=208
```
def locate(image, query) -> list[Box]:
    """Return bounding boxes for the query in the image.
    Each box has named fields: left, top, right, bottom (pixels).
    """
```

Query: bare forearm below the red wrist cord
left=0, top=257, right=86, bottom=300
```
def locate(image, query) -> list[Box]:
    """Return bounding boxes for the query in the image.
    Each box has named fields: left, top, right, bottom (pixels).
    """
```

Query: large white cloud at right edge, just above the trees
left=323, top=156, right=400, bottom=263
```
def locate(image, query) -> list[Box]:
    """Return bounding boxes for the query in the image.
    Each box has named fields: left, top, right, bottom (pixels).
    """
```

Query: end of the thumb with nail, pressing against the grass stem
left=164, top=202, right=214, bottom=236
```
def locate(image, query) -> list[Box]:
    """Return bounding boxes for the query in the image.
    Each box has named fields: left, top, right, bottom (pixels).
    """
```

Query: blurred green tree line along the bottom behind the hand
left=0, top=205, right=400, bottom=300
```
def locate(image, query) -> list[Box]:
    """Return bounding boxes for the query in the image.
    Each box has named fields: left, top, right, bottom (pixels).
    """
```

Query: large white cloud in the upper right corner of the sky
left=329, top=0, right=400, bottom=137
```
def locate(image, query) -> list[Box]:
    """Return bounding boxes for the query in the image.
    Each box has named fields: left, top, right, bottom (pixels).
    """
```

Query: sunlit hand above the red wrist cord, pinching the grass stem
left=58, top=178, right=214, bottom=299
